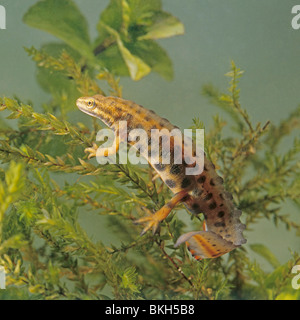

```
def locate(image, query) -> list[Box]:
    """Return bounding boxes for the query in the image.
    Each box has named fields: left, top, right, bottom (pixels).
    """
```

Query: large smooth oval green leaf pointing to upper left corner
left=23, top=0, right=92, bottom=58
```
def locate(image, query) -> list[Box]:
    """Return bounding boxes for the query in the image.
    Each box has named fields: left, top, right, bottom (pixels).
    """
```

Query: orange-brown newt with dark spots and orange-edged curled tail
left=76, top=95, right=246, bottom=260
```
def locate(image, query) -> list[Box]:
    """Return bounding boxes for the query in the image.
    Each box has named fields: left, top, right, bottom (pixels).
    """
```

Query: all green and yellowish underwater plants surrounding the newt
left=0, top=0, right=300, bottom=299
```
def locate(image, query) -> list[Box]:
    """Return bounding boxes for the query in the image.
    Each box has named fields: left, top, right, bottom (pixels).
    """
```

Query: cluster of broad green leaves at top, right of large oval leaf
left=95, top=0, right=184, bottom=80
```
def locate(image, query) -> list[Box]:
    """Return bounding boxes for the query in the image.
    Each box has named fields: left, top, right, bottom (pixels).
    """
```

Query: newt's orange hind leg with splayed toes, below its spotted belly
left=135, top=191, right=187, bottom=235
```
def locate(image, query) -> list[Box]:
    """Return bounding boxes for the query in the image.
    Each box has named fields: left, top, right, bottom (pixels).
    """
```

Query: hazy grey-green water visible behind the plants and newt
left=0, top=0, right=300, bottom=268
